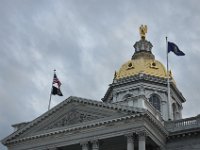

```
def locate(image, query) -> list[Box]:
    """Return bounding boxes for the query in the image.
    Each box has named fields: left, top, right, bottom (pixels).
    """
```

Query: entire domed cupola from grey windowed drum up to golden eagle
left=102, top=25, right=185, bottom=120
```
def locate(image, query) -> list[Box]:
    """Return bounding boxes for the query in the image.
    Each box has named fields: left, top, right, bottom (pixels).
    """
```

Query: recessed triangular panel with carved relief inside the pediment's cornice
left=20, top=101, right=114, bottom=137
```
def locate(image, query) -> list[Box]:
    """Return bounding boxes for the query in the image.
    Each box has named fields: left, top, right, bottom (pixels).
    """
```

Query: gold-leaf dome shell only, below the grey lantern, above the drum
left=115, top=51, right=167, bottom=79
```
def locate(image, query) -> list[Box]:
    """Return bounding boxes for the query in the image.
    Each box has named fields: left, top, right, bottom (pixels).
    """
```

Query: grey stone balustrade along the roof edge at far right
left=165, top=115, right=200, bottom=132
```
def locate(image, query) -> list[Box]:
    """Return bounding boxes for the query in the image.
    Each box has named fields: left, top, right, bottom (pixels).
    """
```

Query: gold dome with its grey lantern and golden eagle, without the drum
left=114, top=25, right=173, bottom=80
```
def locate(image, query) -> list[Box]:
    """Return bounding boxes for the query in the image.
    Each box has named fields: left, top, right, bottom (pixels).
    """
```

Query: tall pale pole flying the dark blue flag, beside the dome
left=166, top=36, right=171, bottom=119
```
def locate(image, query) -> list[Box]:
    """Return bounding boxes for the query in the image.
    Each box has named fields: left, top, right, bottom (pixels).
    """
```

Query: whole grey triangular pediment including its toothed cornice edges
left=3, top=97, right=143, bottom=143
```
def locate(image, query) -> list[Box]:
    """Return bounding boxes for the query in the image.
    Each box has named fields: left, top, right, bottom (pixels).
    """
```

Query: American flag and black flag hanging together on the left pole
left=51, top=73, right=63, bottom=96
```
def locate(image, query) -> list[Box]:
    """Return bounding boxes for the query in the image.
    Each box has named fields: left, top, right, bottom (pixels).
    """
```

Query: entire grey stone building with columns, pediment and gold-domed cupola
left=2, top=26, right=200, bottom=150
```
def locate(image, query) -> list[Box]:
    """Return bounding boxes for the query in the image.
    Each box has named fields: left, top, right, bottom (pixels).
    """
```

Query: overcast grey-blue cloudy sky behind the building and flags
left=0, top=0, right=200, bottom=149
